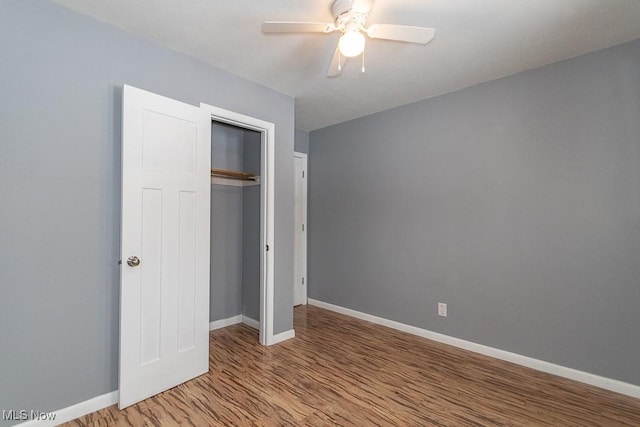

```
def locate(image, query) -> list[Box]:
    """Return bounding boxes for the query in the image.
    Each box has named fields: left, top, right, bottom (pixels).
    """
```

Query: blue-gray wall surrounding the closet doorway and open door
left=0, top=0, right=294, bottom=422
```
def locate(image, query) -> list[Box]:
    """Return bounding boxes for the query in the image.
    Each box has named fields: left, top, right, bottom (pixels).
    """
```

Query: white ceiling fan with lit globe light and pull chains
left=262, top=0, right=436, bottom=77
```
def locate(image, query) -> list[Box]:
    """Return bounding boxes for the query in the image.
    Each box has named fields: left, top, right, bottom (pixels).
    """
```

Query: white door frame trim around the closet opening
left=200, top=103, right=276, bottom=345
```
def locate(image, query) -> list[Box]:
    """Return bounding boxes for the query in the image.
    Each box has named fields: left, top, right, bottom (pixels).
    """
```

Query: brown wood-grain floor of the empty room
left=67, top=306, right=640, bottom=427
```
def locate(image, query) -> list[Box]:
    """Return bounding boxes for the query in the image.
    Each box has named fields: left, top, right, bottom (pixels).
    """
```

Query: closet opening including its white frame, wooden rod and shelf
left=200, top=104, right=275, bottom=345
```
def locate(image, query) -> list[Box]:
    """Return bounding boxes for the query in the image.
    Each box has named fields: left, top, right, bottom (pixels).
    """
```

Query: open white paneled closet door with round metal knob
left=119, top=86, right=211, bottom=408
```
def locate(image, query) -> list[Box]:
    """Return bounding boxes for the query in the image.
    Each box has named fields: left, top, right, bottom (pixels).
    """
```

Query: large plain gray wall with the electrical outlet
left=309, top=41, right=640, bottom=385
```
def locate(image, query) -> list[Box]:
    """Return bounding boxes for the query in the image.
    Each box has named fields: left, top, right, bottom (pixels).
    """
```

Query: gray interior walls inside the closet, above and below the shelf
left=209, top=122, right=262, bottom=321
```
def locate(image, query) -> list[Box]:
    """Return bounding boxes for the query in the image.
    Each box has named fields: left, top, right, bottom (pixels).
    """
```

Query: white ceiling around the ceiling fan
left=53, top=0, right=640, bottom=131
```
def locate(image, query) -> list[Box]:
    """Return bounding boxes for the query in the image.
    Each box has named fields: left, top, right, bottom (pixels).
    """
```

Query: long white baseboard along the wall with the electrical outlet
left=308, top=298, right=640, bottom=398
